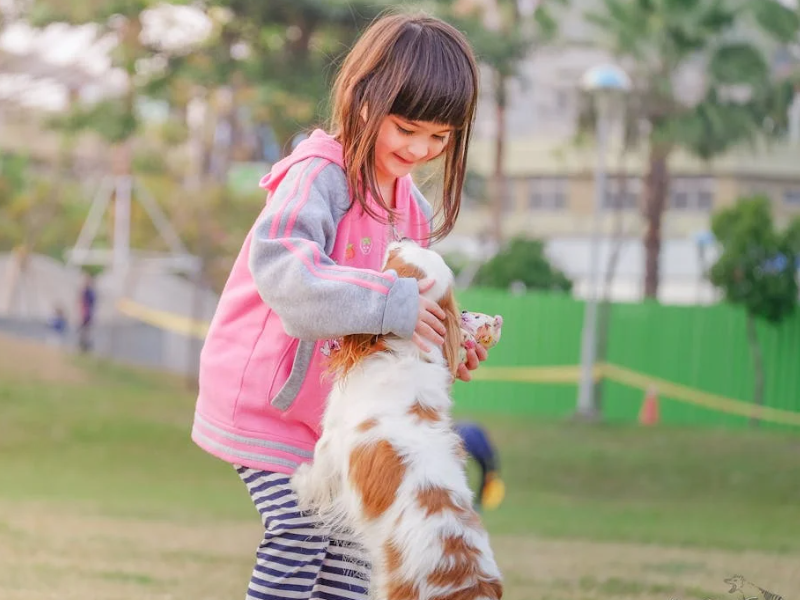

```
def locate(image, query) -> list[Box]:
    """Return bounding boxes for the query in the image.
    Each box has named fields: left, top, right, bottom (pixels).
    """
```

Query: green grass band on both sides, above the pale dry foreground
left=0, top=352, right=800, bottom=553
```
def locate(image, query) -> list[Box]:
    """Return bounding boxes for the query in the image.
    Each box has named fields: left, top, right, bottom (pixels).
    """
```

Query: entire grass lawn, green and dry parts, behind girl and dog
left=0, top=340, right=800, bottom=600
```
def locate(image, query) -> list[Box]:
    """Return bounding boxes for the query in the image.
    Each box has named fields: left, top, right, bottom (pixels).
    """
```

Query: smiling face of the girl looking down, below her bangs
left=375, top=115, right=452, bottom=187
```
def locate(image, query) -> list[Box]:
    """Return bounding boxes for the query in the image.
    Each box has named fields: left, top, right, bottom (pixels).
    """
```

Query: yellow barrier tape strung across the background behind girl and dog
left=117, top=299, right=800, bottom=426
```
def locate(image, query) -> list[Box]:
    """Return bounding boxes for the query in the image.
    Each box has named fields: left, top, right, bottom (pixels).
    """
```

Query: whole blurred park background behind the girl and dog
left=0, top=0, right=800, bottom=600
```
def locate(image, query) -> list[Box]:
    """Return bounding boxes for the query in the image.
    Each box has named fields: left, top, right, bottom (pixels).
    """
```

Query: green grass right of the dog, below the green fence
left=462, top=416, right=800, bottom=552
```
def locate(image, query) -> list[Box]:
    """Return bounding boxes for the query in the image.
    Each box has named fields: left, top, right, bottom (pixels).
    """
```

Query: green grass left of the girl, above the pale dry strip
left=0, top=364, right=252, bottom=519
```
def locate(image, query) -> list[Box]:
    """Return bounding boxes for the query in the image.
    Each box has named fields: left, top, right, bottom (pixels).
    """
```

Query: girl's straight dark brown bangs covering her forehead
left=389, top=27, right=478, bottom=129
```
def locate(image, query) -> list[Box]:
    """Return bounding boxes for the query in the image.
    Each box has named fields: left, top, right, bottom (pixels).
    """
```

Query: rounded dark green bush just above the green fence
left=473, top=238, right=572, bottom=292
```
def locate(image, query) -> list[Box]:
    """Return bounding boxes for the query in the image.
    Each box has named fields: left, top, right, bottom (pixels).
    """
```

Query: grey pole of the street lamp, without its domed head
left=578, top=92, right=611, bottom=419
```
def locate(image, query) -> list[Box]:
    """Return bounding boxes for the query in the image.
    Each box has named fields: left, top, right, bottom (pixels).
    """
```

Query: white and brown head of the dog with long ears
left=329, top=240, right=461, bottom=376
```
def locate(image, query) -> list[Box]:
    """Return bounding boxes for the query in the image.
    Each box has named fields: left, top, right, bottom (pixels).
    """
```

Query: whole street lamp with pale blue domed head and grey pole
left=578, top=64, right=631, bottom=419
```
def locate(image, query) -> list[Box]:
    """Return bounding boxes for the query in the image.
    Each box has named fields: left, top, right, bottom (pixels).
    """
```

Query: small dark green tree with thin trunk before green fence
left=710, top=196, right=800, bottom=425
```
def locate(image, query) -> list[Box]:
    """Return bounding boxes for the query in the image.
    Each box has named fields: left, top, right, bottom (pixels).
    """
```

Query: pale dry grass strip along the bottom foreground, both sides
left=0, top=503, right=800, bottom=600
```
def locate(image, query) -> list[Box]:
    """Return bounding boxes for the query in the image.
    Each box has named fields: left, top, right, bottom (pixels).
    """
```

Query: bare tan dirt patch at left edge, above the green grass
left=0, top=335, right=86, bottom=384
